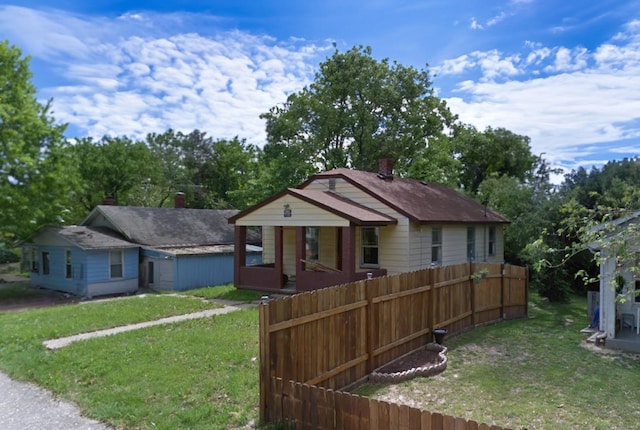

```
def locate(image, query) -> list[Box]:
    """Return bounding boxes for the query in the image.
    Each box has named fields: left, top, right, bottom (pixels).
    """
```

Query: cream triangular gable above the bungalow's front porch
left=236, top=195, right=349, bottom=227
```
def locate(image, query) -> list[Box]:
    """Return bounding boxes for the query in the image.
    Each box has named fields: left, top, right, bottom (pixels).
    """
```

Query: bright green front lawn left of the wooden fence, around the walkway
left=0, top=287, right=259, bottom=429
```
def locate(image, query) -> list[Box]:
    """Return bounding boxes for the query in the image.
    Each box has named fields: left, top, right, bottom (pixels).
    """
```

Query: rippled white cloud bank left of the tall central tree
left=0, top=7, right=329, bottom=145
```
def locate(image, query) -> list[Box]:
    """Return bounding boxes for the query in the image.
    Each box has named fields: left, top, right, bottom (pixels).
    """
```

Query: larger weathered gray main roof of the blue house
left=82, top=205, right=260, bottom=247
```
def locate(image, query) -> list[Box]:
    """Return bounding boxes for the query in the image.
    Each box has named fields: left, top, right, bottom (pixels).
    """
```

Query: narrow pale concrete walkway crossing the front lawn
left=43, top=301, right=257, bottom=349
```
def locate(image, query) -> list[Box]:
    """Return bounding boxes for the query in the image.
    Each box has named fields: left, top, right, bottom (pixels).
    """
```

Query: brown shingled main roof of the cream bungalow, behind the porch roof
left=308, top=168, right=509, bottom=223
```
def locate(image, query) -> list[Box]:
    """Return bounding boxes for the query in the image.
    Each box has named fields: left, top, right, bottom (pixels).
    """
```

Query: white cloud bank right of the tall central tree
left=440, top=21, right=640, bottom=173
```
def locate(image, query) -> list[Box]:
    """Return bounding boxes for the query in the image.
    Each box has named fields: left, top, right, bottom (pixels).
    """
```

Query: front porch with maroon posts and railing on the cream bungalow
left=234, top=225, right=387, bottom=293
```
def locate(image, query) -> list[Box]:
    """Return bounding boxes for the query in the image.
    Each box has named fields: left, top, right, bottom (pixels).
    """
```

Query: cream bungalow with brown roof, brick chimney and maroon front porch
left=229, top=159, right=508, bottom=292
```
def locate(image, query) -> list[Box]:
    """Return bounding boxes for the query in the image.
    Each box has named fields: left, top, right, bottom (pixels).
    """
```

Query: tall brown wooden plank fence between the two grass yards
left=260, top=263, right=528, bottom=430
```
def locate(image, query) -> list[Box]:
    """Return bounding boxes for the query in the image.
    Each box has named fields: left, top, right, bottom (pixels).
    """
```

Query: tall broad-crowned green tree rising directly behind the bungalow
left=262, top=46, right=455, bottom=176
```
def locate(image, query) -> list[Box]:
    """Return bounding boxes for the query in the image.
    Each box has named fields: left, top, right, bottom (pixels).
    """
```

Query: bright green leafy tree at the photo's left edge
left=0, top=41, right=71, bottom=243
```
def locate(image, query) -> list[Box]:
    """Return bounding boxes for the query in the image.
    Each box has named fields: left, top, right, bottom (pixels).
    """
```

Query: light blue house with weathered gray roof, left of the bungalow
left=26, top=199, right=262, bottom=296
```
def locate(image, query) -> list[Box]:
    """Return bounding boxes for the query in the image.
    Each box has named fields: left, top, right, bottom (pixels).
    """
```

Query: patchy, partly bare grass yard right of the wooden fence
left=356, top=295, right=640, bottom=430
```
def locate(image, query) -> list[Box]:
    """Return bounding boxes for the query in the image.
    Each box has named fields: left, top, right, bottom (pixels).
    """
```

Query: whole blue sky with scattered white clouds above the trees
left=0, top=0, right=640, bottom=180
